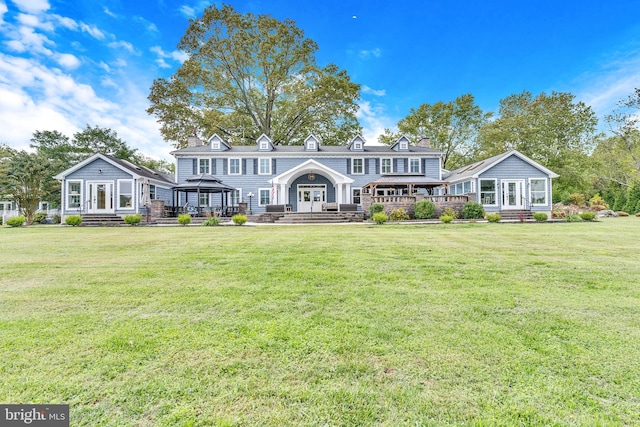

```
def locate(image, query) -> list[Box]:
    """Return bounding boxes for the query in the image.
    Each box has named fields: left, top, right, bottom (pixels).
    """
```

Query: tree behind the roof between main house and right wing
left=380, top=94, right=491, bottom=169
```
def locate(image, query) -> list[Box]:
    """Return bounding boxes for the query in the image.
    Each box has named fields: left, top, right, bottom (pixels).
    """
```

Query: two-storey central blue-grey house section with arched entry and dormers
left=172, top=135, right=445, bottom=214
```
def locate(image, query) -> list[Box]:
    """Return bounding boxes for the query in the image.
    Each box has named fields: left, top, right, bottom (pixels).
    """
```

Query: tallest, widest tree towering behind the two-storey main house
left=147, top=5, right=361, bottom=147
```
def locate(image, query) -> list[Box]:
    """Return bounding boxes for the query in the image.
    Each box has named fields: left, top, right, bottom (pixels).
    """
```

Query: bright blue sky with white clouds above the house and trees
left=0, top=0, right=640, bottom=159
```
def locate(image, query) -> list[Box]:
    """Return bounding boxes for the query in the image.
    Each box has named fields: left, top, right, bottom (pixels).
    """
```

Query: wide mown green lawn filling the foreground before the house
left=0, top=218, right=640, bottom=426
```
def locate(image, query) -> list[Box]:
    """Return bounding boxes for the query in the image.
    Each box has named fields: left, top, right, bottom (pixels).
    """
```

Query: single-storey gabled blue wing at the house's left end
left=55, top=154, right=175, bottom=218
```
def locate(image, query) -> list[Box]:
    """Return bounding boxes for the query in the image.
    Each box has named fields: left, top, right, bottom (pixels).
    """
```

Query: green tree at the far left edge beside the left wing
left=0, top=146, right=50, bottom=225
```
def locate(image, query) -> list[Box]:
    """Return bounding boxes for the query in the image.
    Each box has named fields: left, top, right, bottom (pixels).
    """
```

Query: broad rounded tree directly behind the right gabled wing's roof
left=478, top=91, right=599, bottom=193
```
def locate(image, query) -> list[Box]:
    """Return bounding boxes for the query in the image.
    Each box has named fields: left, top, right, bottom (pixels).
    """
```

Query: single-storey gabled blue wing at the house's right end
left=443, top=150, right=558, bottom=214
